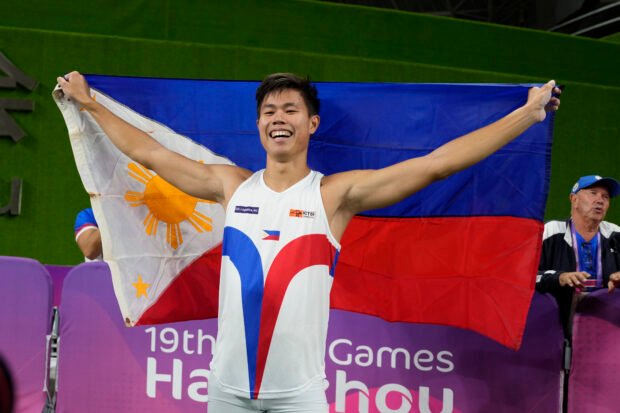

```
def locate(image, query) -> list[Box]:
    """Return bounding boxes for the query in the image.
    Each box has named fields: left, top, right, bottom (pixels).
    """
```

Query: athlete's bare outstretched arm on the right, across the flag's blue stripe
left=324, top=80, right=561, bottom=238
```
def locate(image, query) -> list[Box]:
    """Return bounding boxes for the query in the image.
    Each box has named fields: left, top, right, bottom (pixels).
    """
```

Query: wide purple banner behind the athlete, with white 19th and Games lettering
left=57, top=263, right=562, bottom=413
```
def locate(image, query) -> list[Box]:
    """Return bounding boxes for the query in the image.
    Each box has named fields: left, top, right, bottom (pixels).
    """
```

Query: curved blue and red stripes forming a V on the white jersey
left=222, top=227, right=336, bottom=399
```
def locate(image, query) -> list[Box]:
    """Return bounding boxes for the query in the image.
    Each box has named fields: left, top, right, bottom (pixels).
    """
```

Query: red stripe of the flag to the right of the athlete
left=332, top=217, right=543, bottom=349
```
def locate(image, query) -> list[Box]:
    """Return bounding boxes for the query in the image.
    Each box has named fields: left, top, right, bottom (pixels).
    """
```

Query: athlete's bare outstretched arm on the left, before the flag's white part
left=57, top=72, right=249, bottom=204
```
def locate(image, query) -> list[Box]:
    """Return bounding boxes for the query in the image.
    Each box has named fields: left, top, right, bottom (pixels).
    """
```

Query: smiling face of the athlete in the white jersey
left=256, top=89, right=319, bottom=161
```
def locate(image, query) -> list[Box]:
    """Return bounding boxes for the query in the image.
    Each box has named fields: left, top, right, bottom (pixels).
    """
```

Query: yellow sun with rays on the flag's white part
left=125, top=163, right=214, bottom=249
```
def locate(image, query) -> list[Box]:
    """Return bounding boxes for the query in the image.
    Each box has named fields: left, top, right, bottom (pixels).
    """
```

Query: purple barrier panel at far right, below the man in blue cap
left=568, top=290, right=620, bottom=413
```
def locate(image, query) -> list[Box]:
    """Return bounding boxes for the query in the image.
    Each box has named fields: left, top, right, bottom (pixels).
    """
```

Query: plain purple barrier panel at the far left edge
left=0, top=257, right=52, bottom=413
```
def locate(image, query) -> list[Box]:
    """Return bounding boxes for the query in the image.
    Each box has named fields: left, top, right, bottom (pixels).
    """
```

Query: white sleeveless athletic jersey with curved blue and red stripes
left=211, top=171, right=340, bottom=399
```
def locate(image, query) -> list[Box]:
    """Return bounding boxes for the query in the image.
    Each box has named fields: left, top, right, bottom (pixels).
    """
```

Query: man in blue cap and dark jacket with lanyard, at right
left=536, top=175, right=620, bottom=336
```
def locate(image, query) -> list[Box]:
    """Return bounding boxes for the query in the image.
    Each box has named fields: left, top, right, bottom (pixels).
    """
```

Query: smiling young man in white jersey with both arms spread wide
left=58, top=72, right=560, bottom=412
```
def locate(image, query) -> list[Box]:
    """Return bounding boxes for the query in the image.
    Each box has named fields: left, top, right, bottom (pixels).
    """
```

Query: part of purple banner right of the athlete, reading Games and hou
left=326, top=294, right=563, bottom=413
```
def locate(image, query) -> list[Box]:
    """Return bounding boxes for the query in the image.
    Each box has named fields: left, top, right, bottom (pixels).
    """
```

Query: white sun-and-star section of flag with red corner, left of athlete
left=54, top=85, right=231, bottom=326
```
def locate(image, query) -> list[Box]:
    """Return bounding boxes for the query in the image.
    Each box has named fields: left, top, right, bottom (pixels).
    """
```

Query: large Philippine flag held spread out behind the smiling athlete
left=57, top=76, right=553, bottom=349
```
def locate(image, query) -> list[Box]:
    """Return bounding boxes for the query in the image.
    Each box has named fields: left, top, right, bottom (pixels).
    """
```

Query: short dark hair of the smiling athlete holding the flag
left=256, top=73, right=321, bottom=117
